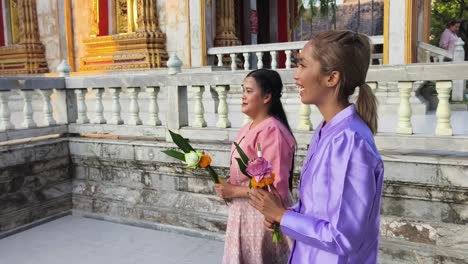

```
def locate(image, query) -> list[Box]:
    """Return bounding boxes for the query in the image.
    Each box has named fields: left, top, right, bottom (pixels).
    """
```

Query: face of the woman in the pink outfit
left=242, top=77, right=271, bottom=118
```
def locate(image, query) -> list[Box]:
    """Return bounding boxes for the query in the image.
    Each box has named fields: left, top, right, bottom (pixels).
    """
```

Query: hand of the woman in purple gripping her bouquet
left=250, top=186, right=287, bottom=224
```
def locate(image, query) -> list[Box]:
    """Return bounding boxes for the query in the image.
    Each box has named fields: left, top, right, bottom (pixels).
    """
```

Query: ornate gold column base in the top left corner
left=0, top=0, right=48, bottom=75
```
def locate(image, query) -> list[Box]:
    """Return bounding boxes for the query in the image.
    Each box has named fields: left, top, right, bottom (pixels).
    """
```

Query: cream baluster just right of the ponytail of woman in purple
left=397, top=82, right=413, bottom=135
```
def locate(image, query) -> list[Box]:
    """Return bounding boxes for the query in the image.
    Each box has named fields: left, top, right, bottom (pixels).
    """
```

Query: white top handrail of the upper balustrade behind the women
left=208, top=36, right=383, bottom=55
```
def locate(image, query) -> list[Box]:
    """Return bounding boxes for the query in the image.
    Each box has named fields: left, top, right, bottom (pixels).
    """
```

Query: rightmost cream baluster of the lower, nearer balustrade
left=435, top=81, right=453, bottom=136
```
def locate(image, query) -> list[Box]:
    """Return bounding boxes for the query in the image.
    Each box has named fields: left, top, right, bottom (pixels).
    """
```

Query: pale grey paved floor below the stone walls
left=0, top=216, right=223, bottom=264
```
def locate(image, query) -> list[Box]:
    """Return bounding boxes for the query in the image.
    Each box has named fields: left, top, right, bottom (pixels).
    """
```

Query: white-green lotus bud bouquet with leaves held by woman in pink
left=162, top=130, right=230, bottom=203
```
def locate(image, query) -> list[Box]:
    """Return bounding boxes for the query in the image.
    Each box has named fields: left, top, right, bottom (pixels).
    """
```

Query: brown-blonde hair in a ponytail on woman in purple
left=310, top=30, right=377, bottom=134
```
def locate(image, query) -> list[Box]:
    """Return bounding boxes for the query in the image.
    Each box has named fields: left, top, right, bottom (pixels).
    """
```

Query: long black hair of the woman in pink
left=245, top=69, right=296, bottom=190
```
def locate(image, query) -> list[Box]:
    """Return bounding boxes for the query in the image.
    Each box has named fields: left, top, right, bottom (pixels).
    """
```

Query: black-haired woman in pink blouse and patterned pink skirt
left=215, top=69, right=296, bottom=264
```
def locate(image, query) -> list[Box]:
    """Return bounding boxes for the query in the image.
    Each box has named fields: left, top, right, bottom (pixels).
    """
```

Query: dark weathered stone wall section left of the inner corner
left=0, top=139, right=72, bottom=236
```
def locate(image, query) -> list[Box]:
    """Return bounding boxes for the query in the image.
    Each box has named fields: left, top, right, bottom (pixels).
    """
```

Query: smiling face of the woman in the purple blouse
left=294, top=43, right=331, bottom=105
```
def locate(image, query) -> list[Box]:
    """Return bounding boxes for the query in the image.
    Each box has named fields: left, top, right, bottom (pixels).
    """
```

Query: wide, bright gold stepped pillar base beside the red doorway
left=79, top=0, right=168, bottom=71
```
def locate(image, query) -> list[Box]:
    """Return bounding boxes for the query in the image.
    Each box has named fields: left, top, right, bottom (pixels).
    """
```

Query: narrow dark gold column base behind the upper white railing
left=214, top=0, right=241, bottom=47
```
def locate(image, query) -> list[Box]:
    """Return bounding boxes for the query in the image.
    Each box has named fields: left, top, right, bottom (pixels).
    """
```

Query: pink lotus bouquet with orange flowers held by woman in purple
left=234, top=142, right=282, bottom=243
